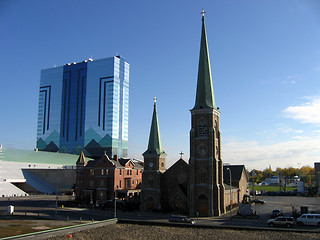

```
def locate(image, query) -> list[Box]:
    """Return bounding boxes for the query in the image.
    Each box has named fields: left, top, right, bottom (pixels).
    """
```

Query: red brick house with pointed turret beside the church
left=75, top=152, right=143, bottom=205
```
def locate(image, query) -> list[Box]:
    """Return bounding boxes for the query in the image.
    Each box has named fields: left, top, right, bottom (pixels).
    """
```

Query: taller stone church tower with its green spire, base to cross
left=188, top=11, right=225, bottom=217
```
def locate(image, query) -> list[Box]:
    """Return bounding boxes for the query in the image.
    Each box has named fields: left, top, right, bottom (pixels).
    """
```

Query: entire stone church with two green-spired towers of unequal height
left=140, top=11, right=247, bottom=217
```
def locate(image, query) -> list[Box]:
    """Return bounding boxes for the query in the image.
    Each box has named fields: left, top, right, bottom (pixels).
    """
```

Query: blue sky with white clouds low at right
left=0, top=0, right=320, bottom=170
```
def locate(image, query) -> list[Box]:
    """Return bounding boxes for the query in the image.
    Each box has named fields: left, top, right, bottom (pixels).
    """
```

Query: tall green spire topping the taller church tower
left=193, top=11, right=217, bottom=109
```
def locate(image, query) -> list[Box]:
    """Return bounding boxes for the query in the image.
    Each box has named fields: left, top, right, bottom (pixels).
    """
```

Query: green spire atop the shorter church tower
left=143, top=98, right=164, bottom=155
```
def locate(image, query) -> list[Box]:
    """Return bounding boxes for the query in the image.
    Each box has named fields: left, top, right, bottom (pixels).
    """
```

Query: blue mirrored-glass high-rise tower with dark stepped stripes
left=37, top=56, right=130, bottom=158
